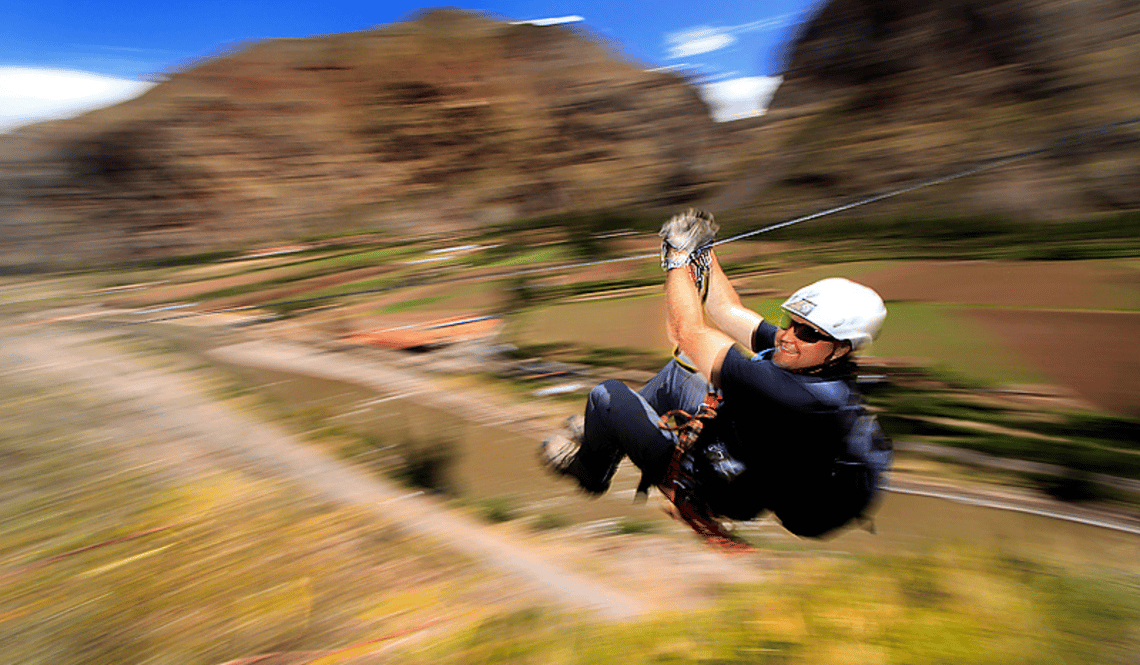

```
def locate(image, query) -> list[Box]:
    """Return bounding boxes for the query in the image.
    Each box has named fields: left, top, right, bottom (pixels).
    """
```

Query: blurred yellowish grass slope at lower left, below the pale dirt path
left=0, top=369, right=482, bottom=665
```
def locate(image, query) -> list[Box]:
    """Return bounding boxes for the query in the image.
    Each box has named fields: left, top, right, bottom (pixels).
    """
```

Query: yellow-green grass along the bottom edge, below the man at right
left=404, top=548, right=1140, bottom=665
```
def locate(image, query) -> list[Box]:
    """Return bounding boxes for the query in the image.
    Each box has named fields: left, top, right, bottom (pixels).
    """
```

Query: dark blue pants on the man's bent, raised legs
left=578, top=360, right=708, bottom=493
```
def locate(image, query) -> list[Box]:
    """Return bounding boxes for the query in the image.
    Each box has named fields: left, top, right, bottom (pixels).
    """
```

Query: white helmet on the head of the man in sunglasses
left=780, top=277, right=887, bottom=349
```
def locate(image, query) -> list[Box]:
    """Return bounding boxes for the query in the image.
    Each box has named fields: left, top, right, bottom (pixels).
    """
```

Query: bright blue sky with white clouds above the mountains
left=0, top=0, right=821, bottom=131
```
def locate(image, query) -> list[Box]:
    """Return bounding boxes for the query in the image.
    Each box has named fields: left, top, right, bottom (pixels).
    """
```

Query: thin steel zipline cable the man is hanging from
left=119, top=116, right=1140, bottom=325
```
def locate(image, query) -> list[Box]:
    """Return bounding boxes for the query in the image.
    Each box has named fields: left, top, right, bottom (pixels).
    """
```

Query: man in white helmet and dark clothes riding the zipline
left=539, top=210, right=891, bottom=546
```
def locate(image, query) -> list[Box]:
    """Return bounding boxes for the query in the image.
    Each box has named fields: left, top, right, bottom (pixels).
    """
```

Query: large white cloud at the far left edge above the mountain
left=0, top=66, right=155, bottom=132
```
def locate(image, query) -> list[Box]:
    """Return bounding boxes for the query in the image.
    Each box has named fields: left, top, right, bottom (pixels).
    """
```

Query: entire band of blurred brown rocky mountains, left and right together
left=0, top=0, right=1140, bottom=267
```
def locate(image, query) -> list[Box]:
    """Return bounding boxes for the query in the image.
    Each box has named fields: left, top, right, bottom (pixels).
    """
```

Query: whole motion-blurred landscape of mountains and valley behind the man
left=0, top=0, right=1140, bottom=665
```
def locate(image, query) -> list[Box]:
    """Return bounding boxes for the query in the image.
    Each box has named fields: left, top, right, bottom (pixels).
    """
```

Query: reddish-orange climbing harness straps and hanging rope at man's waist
left=637, top=391, right=756, bottom=553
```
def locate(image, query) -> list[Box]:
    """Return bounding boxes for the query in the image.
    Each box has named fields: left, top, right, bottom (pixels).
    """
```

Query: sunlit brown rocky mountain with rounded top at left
left=0, top=10, right=726, bottom=263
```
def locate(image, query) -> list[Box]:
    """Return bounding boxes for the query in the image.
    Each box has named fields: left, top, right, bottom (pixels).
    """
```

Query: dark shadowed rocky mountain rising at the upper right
left=719, top=0, right=1140, bottom=220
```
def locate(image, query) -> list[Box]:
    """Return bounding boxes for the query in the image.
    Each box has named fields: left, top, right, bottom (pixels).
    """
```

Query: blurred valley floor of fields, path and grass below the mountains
left=0, top=224, right=1140, bottom=665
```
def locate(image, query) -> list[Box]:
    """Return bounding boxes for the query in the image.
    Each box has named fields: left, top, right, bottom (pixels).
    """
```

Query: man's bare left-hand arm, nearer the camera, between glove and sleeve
left=665, top=267, right=734, bottom=386
